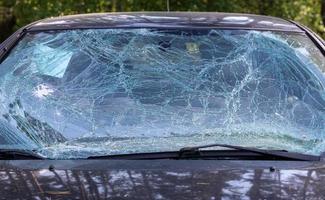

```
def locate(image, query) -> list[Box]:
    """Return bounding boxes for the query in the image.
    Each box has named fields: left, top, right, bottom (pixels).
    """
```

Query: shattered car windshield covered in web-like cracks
left=0, top=29, right=325, bottom=159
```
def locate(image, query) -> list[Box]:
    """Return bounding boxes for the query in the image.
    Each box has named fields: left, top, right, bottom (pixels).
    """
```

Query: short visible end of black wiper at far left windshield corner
left=0, top=149, right=44, bottom=160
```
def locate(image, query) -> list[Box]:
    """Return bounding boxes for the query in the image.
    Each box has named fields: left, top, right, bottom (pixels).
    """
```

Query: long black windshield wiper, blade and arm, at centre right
left=88, top=144, right=320, bottom=161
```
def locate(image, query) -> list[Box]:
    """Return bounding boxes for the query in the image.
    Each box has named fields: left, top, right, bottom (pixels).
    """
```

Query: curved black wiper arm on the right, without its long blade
left=179, top=143, right=320, bottom=161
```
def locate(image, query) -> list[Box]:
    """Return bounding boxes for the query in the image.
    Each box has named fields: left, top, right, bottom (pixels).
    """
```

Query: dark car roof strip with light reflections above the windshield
left=27, top=12, right=303, bottom=32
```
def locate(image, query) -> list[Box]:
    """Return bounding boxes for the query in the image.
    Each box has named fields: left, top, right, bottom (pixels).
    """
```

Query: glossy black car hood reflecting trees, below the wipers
left=0, top=160, right=325, bottom=199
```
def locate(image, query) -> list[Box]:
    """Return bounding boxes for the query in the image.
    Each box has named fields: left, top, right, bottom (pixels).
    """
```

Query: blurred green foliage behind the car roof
left=0, top=0, right=325, bottom=42
